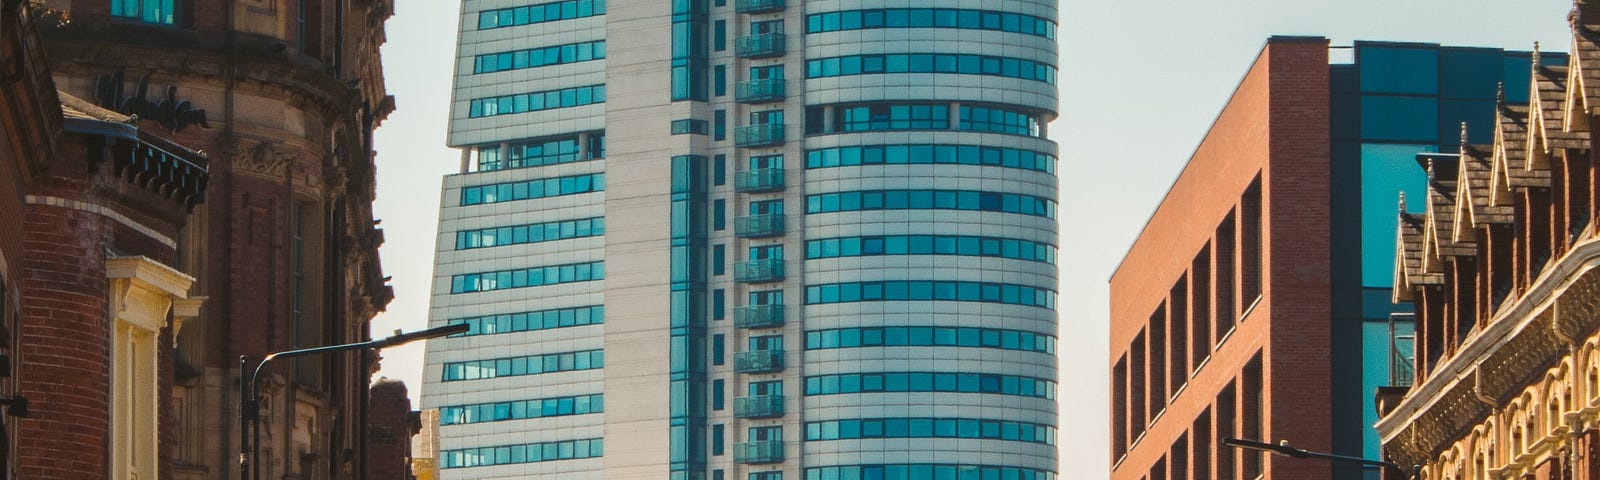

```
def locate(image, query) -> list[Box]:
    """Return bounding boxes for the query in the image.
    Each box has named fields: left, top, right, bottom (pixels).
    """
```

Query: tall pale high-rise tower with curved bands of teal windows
left=422, top=0, right=1058, bottom=480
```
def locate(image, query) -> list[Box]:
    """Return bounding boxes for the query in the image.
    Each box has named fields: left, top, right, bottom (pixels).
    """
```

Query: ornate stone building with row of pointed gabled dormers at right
left=1376, top=0, right=1600, bottom=480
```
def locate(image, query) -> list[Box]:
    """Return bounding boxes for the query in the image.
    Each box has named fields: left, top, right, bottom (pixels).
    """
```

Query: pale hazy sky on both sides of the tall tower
left=373, top=0, right=1571, bottom=478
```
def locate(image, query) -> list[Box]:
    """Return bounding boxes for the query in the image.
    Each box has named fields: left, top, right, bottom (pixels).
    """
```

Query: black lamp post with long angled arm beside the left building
left=238, top=323, right=470, bottom=480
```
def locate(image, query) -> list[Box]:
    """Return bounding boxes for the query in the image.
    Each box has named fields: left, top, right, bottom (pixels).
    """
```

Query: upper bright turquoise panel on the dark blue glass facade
left=1362, top=144, right=1437, bottom=288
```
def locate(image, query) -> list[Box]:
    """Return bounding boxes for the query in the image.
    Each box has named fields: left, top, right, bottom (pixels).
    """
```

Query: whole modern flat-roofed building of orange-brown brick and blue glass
left=1109, top=37, right=1542, bottom=480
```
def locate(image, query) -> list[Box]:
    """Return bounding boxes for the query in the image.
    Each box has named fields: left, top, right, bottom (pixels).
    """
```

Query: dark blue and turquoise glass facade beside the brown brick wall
left=1330, top=42, right=1566, bottom=478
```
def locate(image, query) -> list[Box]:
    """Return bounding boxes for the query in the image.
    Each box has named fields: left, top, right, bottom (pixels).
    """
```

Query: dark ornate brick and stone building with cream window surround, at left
left=0, top=0, right=394, bottom=480
